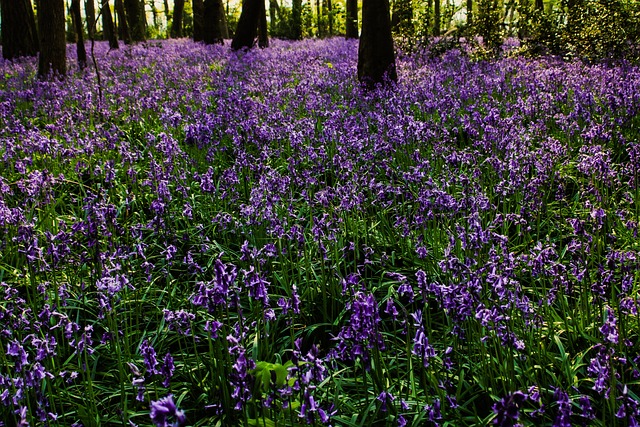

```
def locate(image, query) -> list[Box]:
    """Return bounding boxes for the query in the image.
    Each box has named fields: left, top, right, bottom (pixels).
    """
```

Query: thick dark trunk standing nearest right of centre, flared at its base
left=358, top=0, right=398, bottom=88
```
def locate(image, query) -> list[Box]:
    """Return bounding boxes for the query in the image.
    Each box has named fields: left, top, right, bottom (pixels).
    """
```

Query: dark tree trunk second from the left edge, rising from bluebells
left=37, top=0, right=67, bottom=79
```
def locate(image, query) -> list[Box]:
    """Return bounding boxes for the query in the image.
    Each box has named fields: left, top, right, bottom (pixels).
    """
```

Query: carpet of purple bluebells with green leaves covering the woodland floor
left=0, top=39, right=640, bottom=427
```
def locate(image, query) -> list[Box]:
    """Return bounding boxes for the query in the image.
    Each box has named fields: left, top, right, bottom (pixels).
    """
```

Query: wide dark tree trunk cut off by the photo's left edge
left=0, top=0, right=38, bottom=59
